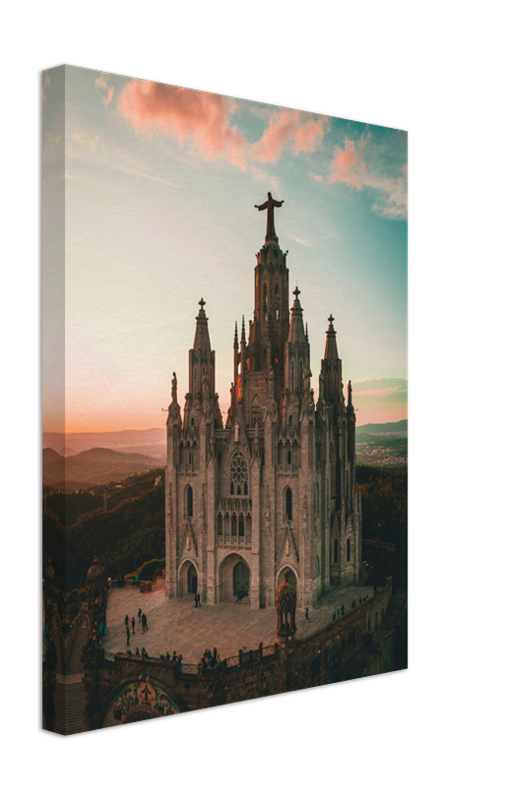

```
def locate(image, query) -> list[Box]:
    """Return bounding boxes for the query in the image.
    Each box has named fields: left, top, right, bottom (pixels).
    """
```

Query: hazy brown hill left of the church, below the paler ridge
left=42, top=447, right=162, bottom=492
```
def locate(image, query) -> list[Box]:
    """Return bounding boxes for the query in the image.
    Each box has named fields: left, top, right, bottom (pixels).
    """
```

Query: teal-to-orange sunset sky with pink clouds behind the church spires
left=42, top=66, right=408, bottom=433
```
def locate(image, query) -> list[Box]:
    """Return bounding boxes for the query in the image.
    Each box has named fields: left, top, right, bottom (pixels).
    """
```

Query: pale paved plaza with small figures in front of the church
left=94, top=586, right=374, bottom=664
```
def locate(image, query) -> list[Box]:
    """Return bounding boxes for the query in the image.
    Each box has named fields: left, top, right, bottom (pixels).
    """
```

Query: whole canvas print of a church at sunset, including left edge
left=42, top=65, right=408, bottom=736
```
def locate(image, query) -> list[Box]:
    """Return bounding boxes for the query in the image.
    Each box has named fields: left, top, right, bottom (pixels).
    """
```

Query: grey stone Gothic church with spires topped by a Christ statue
left=165, top=197, right=362, bottom=610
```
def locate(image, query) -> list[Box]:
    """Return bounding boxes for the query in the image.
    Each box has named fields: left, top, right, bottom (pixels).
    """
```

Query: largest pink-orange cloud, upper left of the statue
left=118, top=81, right=247, bottom=169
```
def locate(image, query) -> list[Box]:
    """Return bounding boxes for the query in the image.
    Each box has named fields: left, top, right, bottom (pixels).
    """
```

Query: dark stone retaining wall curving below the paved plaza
left=83, top=582, right=392, bottom=730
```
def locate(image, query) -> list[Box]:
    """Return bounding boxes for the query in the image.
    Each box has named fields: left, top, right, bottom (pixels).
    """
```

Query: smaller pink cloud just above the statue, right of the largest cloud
left=250, top=108, right=330, bottom=163
